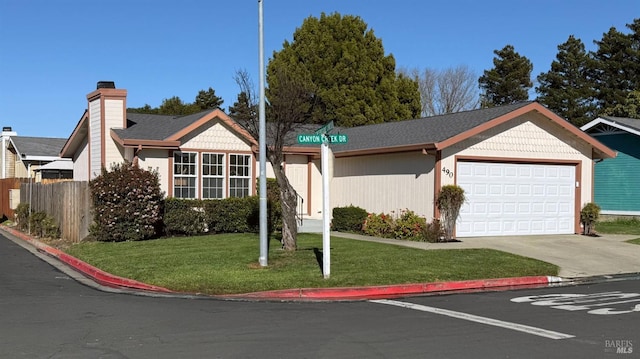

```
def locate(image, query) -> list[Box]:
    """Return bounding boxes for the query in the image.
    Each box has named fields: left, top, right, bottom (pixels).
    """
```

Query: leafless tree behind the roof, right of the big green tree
left=400, top=65, right=479, bottom=117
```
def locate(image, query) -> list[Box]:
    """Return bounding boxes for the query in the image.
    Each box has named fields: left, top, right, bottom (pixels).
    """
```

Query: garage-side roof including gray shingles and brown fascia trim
left=320, top=101, right=615, bottom=158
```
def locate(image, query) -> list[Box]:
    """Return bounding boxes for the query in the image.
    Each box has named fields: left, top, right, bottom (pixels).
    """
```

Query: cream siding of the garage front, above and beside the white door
left=442, top=114, right=592, bottom=207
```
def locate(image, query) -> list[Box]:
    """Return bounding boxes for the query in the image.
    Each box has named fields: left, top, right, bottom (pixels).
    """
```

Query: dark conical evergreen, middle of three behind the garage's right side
left=536, top=35, right=596, bottom=126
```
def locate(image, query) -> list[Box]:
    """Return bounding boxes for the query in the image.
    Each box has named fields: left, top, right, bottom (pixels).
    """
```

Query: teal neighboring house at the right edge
left=581, top=116, right=640, bottom=216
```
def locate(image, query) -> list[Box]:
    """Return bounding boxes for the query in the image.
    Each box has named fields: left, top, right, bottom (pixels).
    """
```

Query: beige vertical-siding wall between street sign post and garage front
left=330, top=152, right=435, bottom=220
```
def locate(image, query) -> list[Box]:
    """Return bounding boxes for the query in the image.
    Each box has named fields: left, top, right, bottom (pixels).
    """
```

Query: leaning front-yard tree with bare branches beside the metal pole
left=234, top=70, right=313, bottom=250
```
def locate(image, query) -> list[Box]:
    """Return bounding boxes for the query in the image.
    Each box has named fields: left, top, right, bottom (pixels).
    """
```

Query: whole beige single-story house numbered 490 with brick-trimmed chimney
left=61, top=83, right=615, bottom=237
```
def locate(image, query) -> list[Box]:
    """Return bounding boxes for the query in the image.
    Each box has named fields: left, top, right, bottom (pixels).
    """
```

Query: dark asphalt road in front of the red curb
left=0, top=233, right=640, bottom=359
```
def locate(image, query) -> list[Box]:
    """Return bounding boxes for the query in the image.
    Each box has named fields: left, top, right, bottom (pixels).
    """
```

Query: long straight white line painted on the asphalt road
left=370, top=299, right=575, bottom=339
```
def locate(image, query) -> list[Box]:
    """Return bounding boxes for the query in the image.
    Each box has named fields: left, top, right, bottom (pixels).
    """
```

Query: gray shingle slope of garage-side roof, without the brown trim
left=331, top=101, right=532, bottom=153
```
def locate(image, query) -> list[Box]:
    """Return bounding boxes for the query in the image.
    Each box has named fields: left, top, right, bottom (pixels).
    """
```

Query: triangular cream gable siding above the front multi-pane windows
left=181, top=121, right=251, bottom=151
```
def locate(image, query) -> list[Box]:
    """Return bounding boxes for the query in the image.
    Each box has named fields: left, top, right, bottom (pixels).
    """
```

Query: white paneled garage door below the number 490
left=456, top=162, right=576, bottom=237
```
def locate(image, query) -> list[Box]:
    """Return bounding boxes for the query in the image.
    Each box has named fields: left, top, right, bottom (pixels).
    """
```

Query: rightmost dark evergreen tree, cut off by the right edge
left=592, top=19, right=640, bottom=112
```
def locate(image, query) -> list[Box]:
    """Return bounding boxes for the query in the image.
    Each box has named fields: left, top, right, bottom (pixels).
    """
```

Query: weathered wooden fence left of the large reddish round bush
left=20, top=181, right=92, bottom=243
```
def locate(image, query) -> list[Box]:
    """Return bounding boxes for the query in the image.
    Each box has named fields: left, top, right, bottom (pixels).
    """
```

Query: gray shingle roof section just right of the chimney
left=113, top=110, right=218, bottom=141
